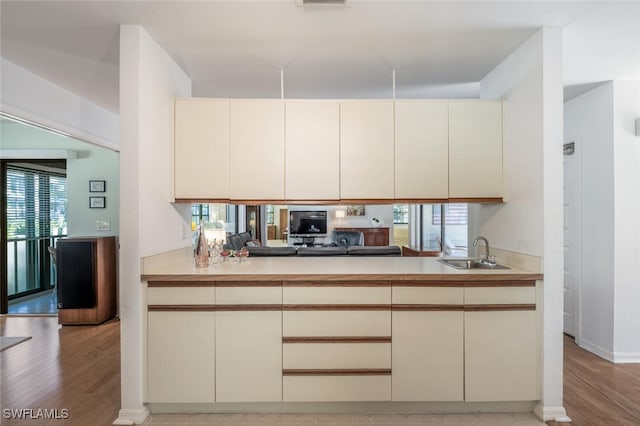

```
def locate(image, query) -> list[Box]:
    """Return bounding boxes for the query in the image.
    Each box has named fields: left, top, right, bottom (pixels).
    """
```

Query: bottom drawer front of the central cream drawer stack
left=282, top=376, right=391, bottom=401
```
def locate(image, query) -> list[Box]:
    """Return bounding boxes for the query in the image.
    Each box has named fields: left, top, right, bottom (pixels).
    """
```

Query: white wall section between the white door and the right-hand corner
left=564, top=83, right=615, bottom=359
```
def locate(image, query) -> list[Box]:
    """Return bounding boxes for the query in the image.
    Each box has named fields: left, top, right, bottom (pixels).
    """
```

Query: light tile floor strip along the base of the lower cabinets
left=144, top=413, right=545, bottom=426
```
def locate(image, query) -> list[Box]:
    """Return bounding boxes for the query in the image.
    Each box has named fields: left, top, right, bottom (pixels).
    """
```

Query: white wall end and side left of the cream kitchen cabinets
left=117, top=25, right=191, bottom=424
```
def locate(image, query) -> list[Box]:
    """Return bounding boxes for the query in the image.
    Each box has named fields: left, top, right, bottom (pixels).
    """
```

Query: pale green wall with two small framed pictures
left=0, top=120, right=120, bottom=237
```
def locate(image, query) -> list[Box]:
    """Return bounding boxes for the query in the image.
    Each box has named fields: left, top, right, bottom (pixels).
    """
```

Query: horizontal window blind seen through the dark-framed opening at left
left=6, top=165, right=67, bottom=240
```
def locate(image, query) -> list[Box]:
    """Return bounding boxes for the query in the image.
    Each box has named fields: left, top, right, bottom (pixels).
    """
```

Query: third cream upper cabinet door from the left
left=285, top=101, right=340, bottom=200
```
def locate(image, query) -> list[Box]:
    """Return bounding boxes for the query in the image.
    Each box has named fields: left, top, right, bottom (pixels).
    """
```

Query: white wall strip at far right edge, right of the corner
left=613, top=81, right=640, bottom=362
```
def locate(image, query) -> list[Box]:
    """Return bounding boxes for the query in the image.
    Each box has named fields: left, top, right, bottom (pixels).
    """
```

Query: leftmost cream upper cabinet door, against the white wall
left=173, top=98, right=229, bottom=200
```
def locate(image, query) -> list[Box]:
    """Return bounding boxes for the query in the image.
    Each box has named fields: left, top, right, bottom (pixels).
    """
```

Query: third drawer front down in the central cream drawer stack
left=282, top=343, right=391, bottom=369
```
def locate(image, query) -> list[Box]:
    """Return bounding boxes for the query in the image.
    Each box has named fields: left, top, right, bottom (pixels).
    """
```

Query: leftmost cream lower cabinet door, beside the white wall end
left=147, top=312, right=215, bottom=402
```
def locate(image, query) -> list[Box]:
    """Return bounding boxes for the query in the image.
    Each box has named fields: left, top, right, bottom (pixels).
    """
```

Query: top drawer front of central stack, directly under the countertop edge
left=282, top=286, right=391, bottom=305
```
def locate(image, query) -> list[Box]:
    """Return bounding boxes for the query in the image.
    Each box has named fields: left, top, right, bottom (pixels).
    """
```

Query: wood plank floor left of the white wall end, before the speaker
left=0, top=316, right=120, bottom=426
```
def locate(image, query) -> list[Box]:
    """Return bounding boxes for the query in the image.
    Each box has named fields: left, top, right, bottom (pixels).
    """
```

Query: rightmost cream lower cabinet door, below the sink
left=464, top=311, right=540, bottom=401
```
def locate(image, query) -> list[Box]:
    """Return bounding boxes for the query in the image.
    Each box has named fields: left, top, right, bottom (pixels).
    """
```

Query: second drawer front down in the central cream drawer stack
left=282, top=311, right=391, bottom=336
